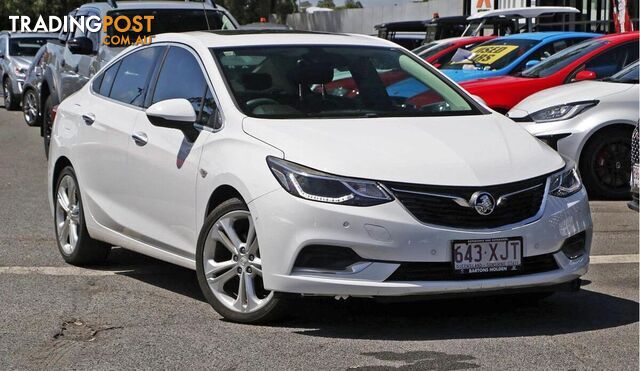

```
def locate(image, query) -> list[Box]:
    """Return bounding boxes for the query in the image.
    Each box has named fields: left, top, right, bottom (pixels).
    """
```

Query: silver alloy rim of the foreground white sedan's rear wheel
left=55, top=175, right=80, bottom=255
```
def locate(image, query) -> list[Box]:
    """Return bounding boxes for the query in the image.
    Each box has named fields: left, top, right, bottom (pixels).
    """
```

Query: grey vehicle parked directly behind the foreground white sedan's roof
left=35, top=0, right=238, bottom=154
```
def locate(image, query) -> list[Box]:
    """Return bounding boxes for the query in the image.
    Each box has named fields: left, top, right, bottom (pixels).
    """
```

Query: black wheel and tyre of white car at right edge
left=580, top=128, right=632, bottom=200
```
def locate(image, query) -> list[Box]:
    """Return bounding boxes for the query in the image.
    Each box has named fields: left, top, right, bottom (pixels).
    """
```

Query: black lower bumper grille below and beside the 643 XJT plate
left=386, top=254, right=558, bottom=281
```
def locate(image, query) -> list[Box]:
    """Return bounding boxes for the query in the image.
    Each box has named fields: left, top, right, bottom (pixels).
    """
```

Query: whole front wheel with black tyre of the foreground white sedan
left=196, top=198, right=289, bottom=324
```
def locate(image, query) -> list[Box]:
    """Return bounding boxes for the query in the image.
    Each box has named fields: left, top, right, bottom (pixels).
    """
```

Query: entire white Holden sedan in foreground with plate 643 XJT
left=48, top=30, right=592, bottom=323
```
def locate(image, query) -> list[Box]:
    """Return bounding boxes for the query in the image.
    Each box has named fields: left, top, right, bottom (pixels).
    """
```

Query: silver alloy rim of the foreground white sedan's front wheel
left=203, top=211, right=274, bottom=313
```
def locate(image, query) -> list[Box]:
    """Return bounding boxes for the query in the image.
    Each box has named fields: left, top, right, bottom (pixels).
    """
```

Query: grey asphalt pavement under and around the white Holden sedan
left=0, top=109, right=639, bottom=370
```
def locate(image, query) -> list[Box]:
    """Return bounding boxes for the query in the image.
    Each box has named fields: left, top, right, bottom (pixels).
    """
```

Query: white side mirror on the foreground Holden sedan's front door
left=147, top=98, right=200, bottom=142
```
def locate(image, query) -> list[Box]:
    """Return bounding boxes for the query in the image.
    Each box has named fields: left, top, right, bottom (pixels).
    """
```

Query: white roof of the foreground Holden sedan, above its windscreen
left=155, top=29, right=398, bottom=48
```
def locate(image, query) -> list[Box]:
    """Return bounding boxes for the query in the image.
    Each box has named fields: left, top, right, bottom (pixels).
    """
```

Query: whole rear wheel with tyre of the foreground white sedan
left=54, top=166, right=111, bottom=266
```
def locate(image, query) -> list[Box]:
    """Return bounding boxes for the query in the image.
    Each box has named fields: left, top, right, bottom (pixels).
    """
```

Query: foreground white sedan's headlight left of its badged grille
left=267, top=157, right=393, bottom=206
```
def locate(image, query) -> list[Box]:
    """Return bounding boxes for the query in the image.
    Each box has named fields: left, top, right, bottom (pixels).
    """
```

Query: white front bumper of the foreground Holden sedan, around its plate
left=249, top=189, right=592, bottom=297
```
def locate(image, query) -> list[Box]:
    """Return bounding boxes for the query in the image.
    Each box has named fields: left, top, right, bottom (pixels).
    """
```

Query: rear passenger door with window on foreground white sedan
left=72, top=47, right=164, bottom=232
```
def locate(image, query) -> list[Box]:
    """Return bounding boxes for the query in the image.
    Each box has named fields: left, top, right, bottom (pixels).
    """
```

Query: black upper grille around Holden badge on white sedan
left=385, top=176, right=547, bottom=229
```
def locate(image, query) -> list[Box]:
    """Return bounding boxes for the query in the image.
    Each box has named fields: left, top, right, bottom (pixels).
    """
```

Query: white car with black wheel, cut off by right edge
left=508, top=62, right=640, bottom=198
